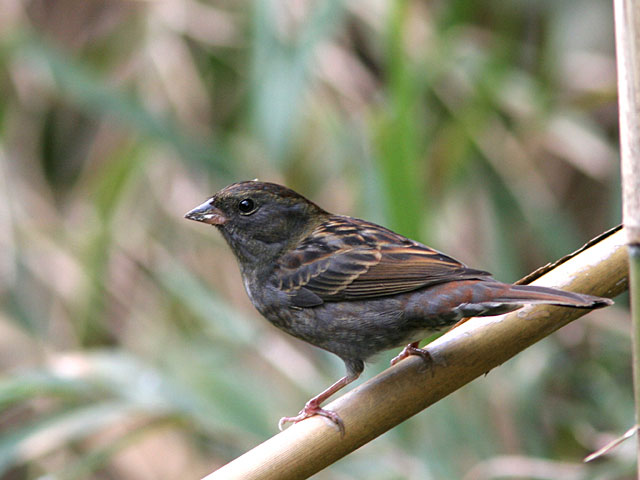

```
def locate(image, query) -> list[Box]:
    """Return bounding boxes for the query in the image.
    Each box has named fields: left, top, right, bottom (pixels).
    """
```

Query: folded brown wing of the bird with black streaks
left=276, top=216, right=490, bottom=306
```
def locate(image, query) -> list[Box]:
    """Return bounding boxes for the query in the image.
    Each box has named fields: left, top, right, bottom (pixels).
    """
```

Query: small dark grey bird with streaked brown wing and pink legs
left=185, top=180, right=613, bottom=435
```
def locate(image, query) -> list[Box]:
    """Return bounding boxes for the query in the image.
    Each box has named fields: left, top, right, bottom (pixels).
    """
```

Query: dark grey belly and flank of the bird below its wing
left=247, top=280, right=484, bottom=360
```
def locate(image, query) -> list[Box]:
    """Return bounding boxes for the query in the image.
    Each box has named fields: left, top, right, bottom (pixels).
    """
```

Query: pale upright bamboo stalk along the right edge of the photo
left=613, top=0, right=640, bottom=479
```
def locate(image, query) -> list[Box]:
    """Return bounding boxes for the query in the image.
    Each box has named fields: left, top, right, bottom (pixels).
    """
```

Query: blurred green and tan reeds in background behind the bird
left=0, top=0, right=635, bottom=480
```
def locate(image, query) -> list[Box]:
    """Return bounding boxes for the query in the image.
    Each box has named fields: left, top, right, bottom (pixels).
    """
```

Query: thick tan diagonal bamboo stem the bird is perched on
left=205, top=230, right=628, bottom=480
